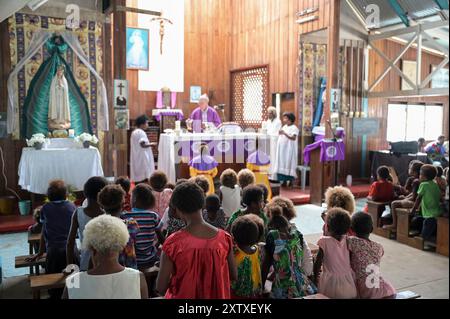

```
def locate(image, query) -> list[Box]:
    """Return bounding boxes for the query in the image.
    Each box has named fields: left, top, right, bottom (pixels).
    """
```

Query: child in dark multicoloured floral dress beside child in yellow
left=261, top=211, right=317, bottom=299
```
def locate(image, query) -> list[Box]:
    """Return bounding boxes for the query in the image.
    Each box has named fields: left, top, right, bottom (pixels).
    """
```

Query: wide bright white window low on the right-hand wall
left=387, top=104, right=444, bottom=142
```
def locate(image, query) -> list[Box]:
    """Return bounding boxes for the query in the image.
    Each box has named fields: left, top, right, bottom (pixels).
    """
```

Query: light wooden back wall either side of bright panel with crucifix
left=127, top=0, right=234, bottom=119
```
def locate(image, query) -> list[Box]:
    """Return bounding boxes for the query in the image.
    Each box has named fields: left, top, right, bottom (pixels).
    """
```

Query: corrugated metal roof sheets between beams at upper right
left=350, top=0, right=440, bottom=28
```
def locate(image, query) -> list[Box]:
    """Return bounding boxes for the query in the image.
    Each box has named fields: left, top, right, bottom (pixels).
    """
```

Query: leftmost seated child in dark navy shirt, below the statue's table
left=27, top=180, right=76, bottom=299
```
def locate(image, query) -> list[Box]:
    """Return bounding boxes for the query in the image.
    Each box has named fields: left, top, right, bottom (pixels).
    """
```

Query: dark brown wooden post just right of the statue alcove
left=109, top=0, right=128, bottom=177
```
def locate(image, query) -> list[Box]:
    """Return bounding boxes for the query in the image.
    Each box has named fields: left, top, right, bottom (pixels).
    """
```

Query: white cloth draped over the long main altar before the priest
left=158, top=132, right=278, bottom=183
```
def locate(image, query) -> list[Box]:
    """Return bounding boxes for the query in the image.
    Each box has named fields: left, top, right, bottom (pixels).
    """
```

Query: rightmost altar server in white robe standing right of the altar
left=274, top=113, right=299, bottom=186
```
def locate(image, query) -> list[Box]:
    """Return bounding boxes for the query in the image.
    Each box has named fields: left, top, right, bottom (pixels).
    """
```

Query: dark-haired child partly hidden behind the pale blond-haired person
left=66, top=177, right=108, bottom=271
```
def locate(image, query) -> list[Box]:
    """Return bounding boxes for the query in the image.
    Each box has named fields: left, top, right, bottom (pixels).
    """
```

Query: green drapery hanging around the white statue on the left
left=22, top=36, right=92, bottom=138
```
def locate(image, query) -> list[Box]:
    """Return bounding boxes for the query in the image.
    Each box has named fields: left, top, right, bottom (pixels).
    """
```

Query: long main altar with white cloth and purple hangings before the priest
left=158, top=132, right=278, bottom=183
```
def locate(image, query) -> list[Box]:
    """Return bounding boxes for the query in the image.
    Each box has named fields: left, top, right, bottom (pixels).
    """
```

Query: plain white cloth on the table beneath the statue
left=19, top=147, right=103, bottom=194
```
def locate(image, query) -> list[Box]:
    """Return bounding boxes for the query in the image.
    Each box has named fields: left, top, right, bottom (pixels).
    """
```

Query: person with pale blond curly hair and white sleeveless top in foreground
left=63, top=215, right=148, bottom=299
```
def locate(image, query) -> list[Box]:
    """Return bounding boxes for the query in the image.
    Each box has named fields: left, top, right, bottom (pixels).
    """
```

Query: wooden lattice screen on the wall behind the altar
left=230, top=66, right=269, bottom=129
